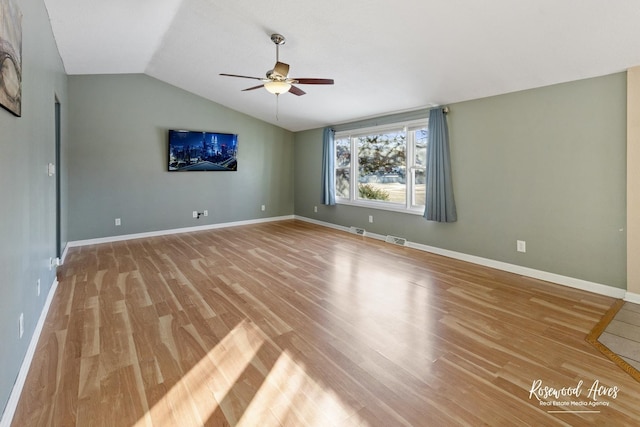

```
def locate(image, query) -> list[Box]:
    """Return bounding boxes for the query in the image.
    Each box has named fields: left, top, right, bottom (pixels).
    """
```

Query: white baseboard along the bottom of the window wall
left=295, top=216, right=624, bottom=302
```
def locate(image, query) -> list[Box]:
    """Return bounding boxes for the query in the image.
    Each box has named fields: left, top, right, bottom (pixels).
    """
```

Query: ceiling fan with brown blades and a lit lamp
left=220, top=34, right=333, bottom=96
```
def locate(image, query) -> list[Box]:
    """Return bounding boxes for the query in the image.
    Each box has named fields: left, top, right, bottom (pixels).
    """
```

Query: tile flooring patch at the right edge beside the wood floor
left=598, top=302, right=640, bottom=371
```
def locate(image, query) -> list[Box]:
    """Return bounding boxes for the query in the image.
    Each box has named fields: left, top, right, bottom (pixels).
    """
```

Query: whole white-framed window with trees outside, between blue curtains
left=335, top=119, right=428, bottom=214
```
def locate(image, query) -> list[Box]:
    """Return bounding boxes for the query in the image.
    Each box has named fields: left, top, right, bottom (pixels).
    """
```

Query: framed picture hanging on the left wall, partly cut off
left=0, top=0, right=22, bottom=117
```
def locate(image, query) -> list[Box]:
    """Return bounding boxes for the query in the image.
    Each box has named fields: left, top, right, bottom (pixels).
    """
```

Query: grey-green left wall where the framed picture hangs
left=0, top=0, right=67, bottom=413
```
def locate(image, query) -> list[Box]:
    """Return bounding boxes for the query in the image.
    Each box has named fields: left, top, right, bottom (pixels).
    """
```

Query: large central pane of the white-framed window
left=357, top=132, right=407, bottom=204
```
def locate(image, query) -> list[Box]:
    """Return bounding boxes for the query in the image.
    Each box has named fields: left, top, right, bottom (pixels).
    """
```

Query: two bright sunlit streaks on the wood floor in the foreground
left=135, top=320, right=369, bottom=427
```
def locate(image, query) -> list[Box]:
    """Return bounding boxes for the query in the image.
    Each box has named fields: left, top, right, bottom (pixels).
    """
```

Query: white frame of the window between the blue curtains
left=333, top=118, right=428, bottom=215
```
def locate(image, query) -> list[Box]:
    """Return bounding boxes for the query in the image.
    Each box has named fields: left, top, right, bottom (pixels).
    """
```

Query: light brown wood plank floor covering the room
left=12, top=220, right=640, bottom=427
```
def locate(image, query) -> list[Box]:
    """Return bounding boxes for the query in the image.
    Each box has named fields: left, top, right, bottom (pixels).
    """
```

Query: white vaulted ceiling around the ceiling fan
left=45, top=0, right=640, bottom=131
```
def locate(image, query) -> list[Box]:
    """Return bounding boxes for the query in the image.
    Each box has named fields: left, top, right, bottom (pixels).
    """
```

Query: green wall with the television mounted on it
left=69, top=75, right=293, bottom=241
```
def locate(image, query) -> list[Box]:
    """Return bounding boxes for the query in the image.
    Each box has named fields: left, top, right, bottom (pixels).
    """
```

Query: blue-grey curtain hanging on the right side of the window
left=424, top=108, right=458, bottom=222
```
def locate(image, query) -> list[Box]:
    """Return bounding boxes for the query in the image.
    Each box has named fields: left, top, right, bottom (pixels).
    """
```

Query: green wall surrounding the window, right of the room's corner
left=295, top=73, right=626, bottom=289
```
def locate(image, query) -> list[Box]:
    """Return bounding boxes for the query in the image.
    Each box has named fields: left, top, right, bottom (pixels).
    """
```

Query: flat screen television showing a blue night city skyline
left=169, top=129, right=238, bottom=172
